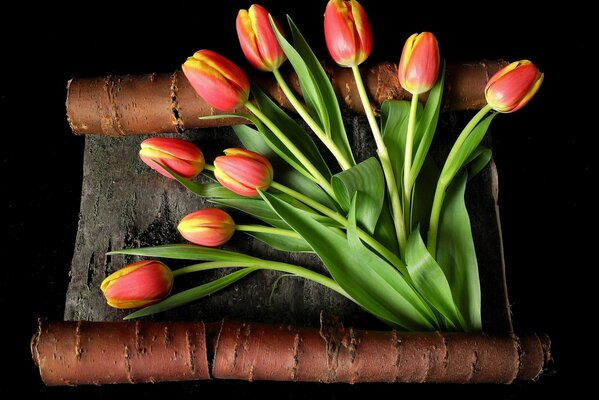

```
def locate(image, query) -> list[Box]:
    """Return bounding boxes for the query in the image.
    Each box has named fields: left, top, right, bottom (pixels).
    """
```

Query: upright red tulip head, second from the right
left=397, top=32, right=440, bottom=94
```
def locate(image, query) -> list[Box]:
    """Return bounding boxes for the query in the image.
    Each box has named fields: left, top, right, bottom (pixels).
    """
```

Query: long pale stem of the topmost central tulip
left=352, top=65, right=407, bottom=255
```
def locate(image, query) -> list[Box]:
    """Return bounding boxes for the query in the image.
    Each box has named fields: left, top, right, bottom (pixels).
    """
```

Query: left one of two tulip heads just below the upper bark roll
left=139, top=138, right=204, bottom=179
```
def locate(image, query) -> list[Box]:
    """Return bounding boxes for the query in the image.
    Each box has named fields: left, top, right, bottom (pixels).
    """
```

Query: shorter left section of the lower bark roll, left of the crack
left=31, top=320, right=210, bottom=386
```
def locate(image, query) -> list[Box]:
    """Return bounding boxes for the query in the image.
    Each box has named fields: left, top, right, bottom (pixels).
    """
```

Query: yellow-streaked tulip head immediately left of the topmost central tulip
left=236, top=4, right=287, bottom=71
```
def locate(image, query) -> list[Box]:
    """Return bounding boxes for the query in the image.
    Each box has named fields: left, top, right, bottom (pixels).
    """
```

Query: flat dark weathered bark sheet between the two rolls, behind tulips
left=64, top=115, right=511, bottom=332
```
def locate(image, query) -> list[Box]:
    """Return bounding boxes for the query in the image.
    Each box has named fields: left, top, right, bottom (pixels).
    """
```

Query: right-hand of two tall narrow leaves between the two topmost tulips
left=287, top=16, right=355, bottom=165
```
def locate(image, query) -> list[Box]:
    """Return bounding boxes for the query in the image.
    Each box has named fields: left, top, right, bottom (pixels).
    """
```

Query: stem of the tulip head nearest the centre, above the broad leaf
left=270, top=182, right=408, bottom=276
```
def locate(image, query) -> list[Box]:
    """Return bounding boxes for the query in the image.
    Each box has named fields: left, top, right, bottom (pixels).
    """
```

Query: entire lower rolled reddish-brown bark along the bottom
left=32, top=320, right=550, bottom=385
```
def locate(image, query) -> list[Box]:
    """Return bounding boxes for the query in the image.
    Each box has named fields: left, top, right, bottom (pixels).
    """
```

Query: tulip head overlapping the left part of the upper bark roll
left=182, top=50, right=250, bottom=111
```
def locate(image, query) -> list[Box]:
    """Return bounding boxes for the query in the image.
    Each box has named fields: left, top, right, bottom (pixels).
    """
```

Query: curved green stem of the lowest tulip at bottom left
left=173, top=259, right=355, bottom=301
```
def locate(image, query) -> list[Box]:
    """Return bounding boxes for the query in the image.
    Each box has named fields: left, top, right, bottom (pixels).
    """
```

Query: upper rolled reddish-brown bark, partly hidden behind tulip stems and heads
left=66, top=60, right=507, bottom=136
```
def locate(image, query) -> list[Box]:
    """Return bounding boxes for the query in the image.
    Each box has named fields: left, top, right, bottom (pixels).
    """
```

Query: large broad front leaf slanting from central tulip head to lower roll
left=260, top=192, right=434, bottom=330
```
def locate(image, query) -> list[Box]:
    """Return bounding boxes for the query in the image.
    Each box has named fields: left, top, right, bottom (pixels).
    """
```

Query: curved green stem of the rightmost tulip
left=426, top=104, right=491, bottom=257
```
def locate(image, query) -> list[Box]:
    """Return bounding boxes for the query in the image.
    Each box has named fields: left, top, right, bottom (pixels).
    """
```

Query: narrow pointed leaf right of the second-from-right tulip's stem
left=408, top=62, right=445, bottom=187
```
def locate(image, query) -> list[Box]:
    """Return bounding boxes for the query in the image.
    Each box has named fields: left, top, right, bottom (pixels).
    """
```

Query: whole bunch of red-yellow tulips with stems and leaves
left=101, top=0, right=543, bottom=331
